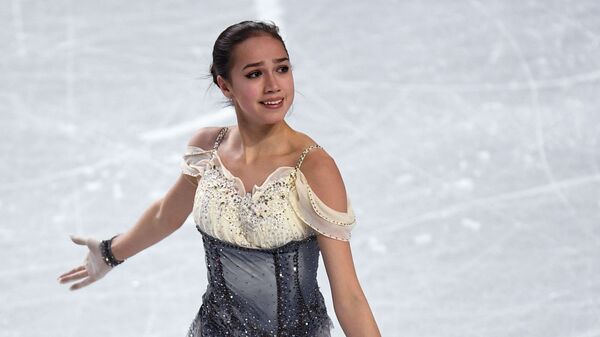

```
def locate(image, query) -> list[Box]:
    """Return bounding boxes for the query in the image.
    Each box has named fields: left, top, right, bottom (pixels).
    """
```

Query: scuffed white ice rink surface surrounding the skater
left=0, top=0, right=600, bottom=337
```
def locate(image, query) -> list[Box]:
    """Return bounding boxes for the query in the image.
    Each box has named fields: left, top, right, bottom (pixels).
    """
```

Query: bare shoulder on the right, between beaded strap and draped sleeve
left=300, top=143, right=347, bottom=212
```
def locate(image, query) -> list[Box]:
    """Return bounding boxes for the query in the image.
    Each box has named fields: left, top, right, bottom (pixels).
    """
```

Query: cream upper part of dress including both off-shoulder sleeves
left=181, top=146, right=356, bottom=248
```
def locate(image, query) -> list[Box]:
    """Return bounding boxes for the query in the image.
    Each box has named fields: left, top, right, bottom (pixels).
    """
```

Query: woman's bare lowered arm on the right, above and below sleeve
left=303, top=151, right=381, bottom=337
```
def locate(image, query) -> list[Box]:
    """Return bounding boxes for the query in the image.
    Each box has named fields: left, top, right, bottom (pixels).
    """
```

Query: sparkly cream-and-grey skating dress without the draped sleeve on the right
left=182, top=128, right=352, bottom=337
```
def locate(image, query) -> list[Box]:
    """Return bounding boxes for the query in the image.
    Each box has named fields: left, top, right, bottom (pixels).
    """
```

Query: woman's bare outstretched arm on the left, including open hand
left=58, top=127, right=219, bottom=290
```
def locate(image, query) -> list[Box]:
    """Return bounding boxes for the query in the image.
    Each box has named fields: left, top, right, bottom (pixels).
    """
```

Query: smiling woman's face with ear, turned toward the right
left=217, top=35, right=294, bottom=124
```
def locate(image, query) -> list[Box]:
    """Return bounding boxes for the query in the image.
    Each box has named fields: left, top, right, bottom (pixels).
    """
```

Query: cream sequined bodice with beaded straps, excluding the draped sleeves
left=193, top=127, right=319, bottom=248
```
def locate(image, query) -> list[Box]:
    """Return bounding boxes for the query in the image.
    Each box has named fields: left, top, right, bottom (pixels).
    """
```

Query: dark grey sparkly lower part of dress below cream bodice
left=187, top=228, right=333, bottom=337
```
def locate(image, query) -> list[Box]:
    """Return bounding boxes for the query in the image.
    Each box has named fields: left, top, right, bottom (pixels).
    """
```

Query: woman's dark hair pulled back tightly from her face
left=210, top=21, right=289, bottom=86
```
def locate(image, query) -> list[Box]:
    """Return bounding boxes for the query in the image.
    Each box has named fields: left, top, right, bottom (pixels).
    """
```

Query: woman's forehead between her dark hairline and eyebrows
left=231, top=35, right=288, bottom=68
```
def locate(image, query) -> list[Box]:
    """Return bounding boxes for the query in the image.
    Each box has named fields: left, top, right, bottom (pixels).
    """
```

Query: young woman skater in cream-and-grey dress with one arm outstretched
left=59, top=21, right=380, bottom=337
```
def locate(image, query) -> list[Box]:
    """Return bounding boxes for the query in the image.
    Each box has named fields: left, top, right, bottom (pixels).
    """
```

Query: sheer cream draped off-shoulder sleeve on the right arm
left=289, top=170, right=356, bottom=241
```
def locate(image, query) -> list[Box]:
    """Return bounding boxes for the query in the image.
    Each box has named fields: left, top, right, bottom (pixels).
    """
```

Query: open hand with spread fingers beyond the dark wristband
left=58, top=235, right=112, bottom=290
